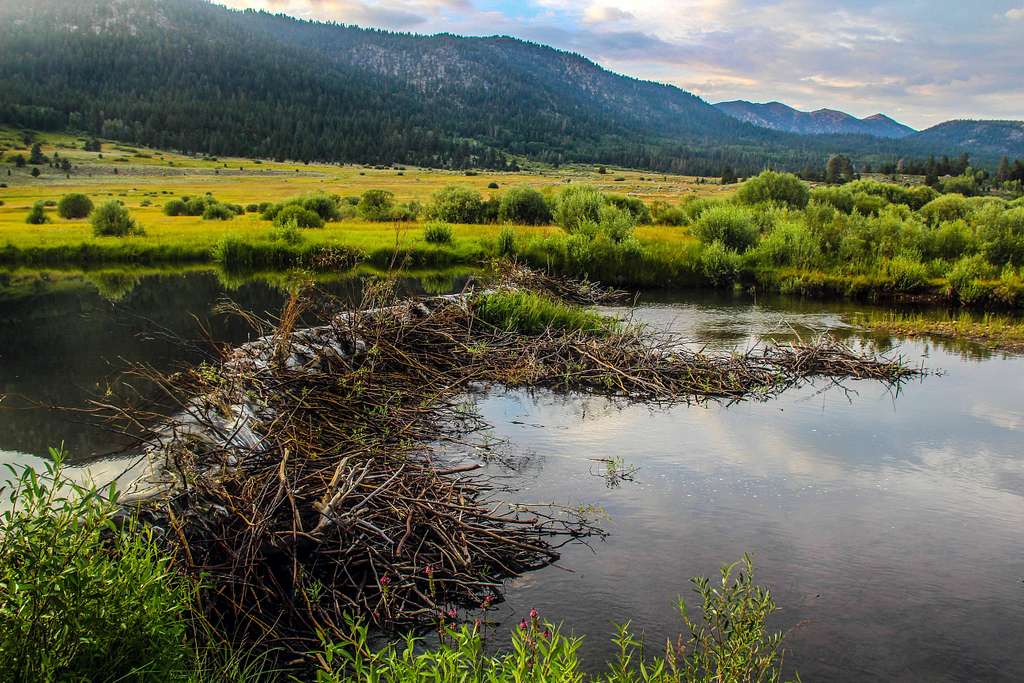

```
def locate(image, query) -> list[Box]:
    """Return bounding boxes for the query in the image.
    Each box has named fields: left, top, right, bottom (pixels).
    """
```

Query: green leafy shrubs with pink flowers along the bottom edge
left=316, top=556, right=799, bottom=683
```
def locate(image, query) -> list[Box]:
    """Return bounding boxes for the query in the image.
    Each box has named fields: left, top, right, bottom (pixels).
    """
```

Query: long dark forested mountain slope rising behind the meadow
left=0, top=0, right=1024, bottom=175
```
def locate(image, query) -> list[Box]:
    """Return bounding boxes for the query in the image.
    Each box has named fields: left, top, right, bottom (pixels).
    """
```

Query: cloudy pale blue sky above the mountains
left=217, top=0, right=1024, bottom=128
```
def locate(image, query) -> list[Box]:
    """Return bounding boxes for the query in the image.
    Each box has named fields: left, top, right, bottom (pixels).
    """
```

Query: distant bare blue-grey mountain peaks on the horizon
left=715, top=99, right=916, bottom=139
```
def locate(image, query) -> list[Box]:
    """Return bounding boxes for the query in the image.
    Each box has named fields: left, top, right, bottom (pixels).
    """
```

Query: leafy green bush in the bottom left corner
left=0, top=452, right=195, bottom=681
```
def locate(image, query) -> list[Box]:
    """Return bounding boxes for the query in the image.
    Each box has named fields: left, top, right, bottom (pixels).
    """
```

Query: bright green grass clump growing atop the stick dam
left=474, top=291, right=620, bottom=335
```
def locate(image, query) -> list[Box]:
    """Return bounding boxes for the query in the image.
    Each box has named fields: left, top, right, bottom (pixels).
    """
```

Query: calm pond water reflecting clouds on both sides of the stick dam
left=0, top=273, right=1024, bottom=681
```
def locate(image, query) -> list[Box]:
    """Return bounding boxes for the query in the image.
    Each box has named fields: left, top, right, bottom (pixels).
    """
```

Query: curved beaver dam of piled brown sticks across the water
left=105, top=266, right=922, bottom=654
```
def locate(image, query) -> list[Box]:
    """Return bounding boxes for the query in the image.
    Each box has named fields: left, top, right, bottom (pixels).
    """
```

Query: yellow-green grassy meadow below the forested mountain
left=0, top=129, right=731, bottom=266
